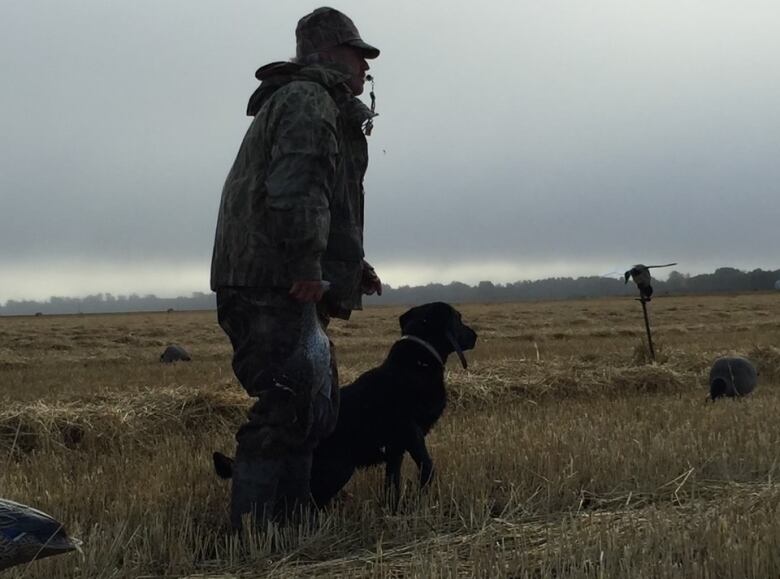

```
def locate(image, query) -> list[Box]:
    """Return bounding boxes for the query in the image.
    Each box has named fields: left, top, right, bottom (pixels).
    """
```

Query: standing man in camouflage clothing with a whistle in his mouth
left=211, top=8, right=382, bottom=529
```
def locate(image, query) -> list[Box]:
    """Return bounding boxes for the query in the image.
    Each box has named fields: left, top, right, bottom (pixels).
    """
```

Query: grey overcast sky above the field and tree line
left=0, top=0, right=780, bottom=302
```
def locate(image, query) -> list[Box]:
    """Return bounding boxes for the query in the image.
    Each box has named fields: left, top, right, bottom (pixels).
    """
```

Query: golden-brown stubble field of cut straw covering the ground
left=0, top=294, right=780, bottom=578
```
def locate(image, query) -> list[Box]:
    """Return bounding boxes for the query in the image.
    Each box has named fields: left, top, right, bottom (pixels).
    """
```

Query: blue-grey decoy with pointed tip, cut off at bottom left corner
left=0, top=499, right=81, bottom=570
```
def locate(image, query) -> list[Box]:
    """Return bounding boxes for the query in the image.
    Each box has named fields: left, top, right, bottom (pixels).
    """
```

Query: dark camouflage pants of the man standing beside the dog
left=217, top=288, right=339, bottom=458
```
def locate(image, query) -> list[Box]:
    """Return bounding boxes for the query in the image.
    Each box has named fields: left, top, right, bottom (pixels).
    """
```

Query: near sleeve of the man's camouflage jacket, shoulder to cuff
left=266, top=82, right=338, bottom=280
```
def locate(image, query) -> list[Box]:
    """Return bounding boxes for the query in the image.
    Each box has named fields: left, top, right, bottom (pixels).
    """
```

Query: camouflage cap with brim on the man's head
left=295, top=6, right=379, bottom=58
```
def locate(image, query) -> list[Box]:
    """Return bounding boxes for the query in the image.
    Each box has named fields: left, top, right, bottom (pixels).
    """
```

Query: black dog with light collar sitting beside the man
left=214, top=302, right=477, bottom=508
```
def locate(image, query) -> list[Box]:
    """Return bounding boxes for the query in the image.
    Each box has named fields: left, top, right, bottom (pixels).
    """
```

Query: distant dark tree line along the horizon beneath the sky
left=0, top=267, right=780, bottom=316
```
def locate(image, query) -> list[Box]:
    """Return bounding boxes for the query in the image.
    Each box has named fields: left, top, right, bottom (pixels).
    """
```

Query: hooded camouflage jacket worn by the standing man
left=211, top=63, right=372, bottom=317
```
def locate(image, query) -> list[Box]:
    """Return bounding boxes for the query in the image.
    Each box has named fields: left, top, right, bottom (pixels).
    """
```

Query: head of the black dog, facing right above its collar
left=398, top=302, right=477, bottom=368
